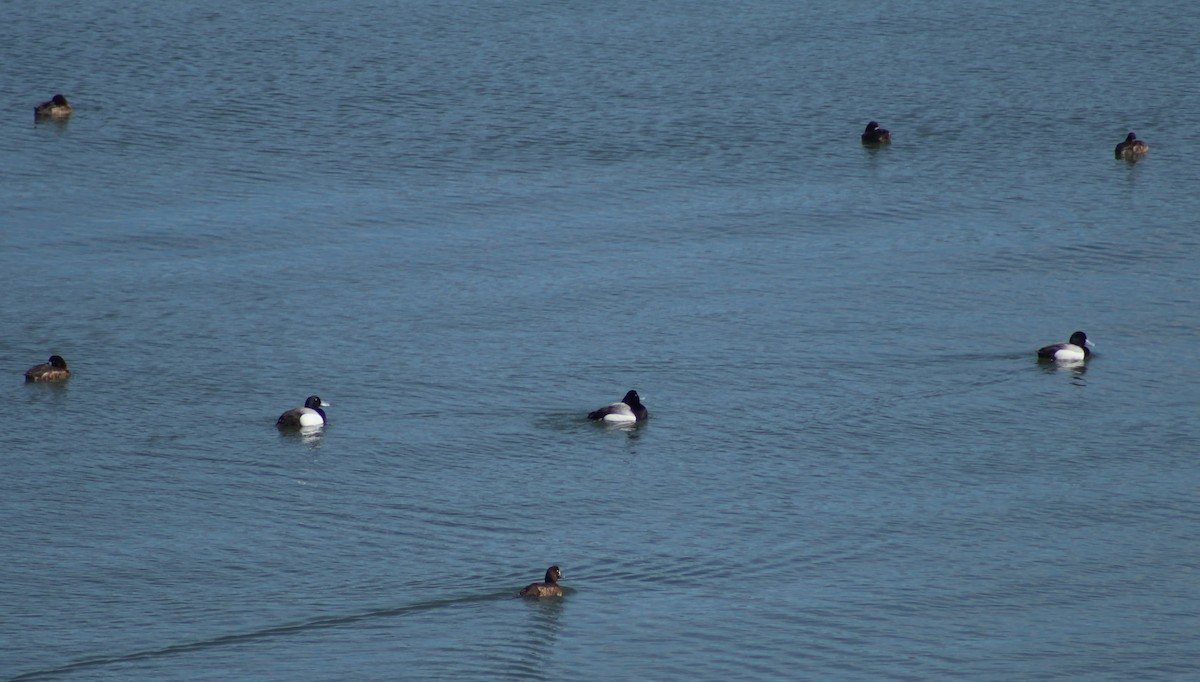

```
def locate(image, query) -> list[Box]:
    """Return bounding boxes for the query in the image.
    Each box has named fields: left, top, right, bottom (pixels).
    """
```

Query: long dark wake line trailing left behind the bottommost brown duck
left=8, top=590, right=520, bottom=682
